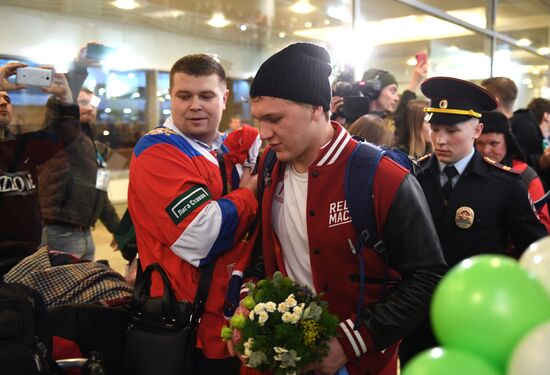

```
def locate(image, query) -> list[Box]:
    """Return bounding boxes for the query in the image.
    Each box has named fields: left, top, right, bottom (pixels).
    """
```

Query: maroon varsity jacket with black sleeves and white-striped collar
left=260, top=122, right=445, bottom=375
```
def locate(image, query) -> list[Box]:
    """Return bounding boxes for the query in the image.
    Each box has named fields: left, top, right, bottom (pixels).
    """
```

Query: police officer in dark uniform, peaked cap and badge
left=400, top=77, right=548, bottom=363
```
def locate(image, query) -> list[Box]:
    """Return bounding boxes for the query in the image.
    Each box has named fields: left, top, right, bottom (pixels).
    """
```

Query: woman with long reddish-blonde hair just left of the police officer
left=397, top=99, right=431, bottom=158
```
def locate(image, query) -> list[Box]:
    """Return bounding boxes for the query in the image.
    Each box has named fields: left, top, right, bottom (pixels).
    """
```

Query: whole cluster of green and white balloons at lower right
left=403, top=236, right=550, bottom=375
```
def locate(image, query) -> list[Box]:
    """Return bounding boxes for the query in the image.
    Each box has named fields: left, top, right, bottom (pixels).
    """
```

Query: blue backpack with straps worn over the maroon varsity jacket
left=258, top=141, right=417, bottom=327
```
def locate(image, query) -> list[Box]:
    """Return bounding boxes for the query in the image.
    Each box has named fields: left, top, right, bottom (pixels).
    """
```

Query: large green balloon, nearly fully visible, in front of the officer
left=431, top=255, right=550, bottom=371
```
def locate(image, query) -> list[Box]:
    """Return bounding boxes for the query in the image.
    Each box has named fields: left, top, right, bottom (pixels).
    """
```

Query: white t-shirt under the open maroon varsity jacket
left=271, top=163, right=315, bottom=292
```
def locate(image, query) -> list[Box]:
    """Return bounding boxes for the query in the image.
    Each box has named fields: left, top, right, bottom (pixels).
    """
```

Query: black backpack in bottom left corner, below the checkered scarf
left=0, top=283, right=58, bottom=375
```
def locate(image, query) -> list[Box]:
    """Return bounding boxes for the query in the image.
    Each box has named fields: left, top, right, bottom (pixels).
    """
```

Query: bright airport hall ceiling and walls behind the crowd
left=0, top=0, right=550, bottom=272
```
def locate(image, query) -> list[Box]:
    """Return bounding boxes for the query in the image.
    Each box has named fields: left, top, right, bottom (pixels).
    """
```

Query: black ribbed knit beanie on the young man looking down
left=250, top=43, right=332, bottom=111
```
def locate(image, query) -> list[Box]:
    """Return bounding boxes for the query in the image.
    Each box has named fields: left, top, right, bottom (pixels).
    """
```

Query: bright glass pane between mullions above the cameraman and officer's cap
left=356, top=0, right=491, bottom=84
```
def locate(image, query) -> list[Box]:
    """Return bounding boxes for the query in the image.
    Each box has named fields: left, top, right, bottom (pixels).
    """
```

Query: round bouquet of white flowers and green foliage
left=230, top=272, right=339, bottom=375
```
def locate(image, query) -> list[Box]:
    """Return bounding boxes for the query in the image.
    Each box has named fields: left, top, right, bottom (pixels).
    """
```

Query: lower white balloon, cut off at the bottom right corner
left=507, top=317, right=550, bottom=375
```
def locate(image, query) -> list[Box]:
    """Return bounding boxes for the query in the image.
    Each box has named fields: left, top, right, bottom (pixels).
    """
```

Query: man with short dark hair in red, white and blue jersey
left=128, top=54, right=258, bottom=374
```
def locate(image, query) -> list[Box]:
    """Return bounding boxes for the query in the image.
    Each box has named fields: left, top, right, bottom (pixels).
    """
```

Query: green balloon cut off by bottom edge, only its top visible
left=402, top=348, right=500, bottom=375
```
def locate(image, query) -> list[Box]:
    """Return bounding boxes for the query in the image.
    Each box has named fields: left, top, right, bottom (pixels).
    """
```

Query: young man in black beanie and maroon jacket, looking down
left=246, top=43, right=445, bottom=375
